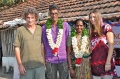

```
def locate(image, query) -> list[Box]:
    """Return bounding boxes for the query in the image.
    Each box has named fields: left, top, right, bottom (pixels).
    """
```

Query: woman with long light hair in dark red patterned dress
left=89, top=10, right=115, bottom=79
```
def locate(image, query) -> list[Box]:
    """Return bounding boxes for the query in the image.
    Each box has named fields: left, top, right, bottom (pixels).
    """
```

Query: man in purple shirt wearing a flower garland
left=42, top=4, right=69, bottom=79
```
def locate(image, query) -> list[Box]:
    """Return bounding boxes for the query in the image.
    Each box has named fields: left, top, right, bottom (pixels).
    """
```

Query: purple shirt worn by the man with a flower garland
left=42, top=22, right=70, bottom=63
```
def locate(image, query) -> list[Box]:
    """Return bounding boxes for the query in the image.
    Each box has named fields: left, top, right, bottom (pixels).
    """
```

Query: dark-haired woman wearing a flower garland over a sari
left=67, top=19, right=91, bottom=79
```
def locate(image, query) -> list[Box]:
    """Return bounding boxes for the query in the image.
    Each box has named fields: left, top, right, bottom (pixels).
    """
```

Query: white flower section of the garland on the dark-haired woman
left=72, top=35, right=89, bottom=66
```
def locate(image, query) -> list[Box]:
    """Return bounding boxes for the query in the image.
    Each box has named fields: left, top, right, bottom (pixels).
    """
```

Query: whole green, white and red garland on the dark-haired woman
left=71, top=28, right=89, bottom=66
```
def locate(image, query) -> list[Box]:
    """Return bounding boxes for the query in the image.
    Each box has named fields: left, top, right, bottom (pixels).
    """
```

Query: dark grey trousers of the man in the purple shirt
left=46, top=62, right=69, bottom=79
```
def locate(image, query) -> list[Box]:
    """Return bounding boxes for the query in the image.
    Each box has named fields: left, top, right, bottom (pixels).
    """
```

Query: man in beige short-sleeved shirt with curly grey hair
left=13, top=7, right=45, bottom=79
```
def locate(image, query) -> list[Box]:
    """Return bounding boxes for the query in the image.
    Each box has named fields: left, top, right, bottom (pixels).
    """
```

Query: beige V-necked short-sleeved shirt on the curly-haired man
left=13, top=25, right=43, bottom=69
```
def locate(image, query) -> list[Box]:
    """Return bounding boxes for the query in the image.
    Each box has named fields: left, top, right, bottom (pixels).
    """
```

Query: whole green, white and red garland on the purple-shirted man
left=46, top=19, right=63, bottom=56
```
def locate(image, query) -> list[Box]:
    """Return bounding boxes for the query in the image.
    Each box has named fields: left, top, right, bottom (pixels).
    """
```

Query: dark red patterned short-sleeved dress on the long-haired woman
left=91, top=24, right=115, bottom=76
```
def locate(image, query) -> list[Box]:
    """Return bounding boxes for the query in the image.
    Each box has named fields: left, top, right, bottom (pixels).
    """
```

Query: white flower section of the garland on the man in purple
left=46, top=29, right=63, bottom=56
